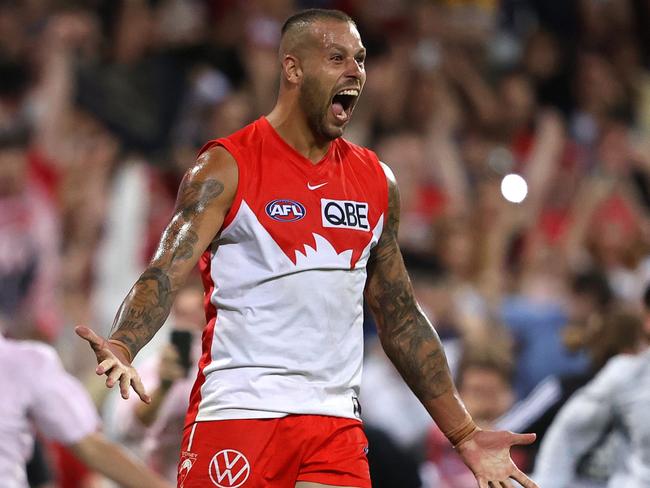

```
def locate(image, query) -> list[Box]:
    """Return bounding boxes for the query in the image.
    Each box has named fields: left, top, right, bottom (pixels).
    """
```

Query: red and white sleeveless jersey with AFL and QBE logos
left=187, top=117, right=388, bottom=424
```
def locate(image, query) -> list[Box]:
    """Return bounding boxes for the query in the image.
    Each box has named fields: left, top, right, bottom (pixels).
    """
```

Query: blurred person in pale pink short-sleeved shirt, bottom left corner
left=0, top=328, right=170, bottom=488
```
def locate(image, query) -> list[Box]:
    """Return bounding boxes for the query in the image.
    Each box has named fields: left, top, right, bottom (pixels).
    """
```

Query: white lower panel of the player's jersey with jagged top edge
left=192, top=201, right=381, bottom=420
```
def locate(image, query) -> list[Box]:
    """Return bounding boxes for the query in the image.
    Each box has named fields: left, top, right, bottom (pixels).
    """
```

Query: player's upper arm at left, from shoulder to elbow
left=149, top=146, right=238, bottom=286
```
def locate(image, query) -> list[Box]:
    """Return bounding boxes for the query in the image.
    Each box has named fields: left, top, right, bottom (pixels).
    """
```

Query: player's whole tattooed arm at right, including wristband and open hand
left=365, top=166, right=536, bottom=488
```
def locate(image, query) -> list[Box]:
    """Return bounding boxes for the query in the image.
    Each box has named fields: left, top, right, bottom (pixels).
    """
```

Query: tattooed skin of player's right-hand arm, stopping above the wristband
left=365, top=167, right=467, bottom=431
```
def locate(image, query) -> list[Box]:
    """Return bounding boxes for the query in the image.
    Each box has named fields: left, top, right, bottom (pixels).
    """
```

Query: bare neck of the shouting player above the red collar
left=266, top=103, right=332, bottom=164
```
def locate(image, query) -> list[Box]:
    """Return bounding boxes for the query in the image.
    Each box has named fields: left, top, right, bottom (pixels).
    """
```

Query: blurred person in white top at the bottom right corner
left=534, top=306, right=650, bottom=488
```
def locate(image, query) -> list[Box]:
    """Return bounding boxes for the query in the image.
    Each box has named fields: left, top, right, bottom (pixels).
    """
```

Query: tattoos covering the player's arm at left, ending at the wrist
left=111, top=162, right=224, bottom=357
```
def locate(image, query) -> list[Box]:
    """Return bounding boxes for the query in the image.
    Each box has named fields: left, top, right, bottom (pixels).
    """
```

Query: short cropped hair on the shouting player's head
left=279, top=8, right=356, bottom=59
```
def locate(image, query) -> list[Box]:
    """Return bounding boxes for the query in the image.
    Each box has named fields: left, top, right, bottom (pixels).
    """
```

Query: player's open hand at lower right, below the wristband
left=456, top=430, right=538, bottom=488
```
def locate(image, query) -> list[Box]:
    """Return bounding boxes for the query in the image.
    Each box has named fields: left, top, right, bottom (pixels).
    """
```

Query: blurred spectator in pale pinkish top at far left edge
left=0, top=126, right=61, bottom=342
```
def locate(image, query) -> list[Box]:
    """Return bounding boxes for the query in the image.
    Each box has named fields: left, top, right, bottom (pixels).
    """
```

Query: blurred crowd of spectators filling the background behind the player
left=0, top=0, right=650, bottom=488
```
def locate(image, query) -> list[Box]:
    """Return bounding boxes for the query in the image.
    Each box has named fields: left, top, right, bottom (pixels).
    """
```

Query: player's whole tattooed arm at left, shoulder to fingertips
left=76, top=147, right=238, bottom=401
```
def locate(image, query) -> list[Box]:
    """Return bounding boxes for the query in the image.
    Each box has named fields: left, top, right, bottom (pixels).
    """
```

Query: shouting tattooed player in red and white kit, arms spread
left=77, top=10, right=536, bottom=488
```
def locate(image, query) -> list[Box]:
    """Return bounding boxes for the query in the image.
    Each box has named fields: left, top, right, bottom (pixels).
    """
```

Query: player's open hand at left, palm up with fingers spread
left=74, top=325, right=151, bottom=403
